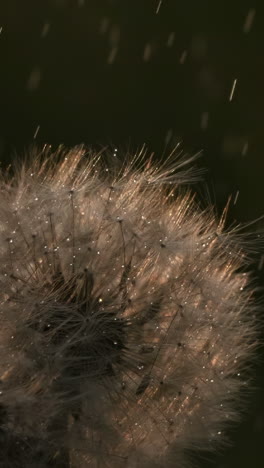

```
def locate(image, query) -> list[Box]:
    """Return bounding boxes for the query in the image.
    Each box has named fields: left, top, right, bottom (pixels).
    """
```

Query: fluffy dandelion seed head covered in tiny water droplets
left=0, top=147, right=256, bottom=468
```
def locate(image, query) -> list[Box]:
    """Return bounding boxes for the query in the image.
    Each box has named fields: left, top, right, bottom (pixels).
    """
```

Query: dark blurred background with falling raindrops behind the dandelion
left=0, top=0, right=264, bottom=468
